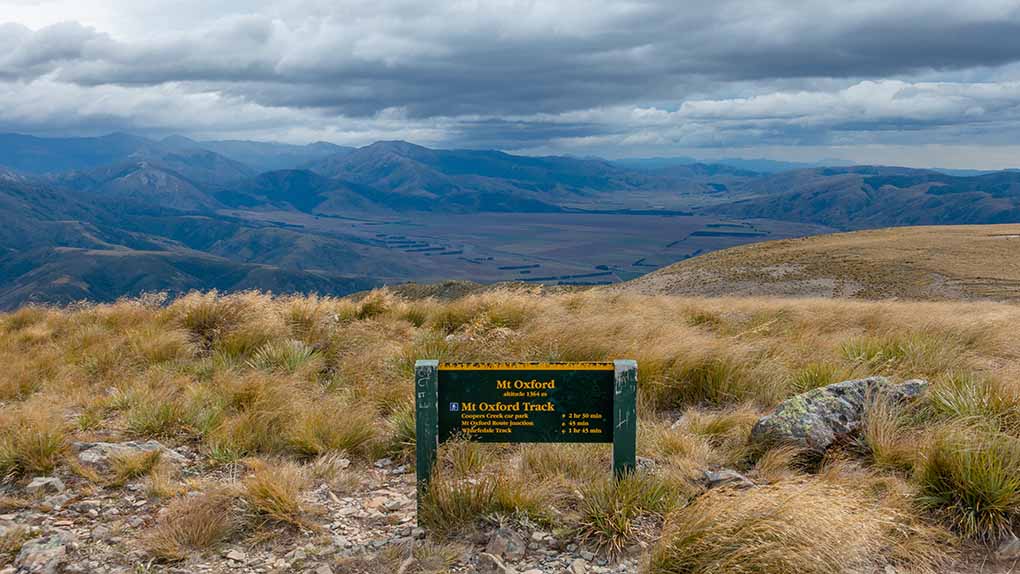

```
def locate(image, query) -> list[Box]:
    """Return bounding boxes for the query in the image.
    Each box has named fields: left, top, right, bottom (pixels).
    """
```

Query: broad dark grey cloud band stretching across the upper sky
left=7, top=2, right=1020, bottom=116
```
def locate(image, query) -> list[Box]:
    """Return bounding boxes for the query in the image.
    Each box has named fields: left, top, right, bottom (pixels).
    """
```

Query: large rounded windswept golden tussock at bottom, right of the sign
left=649, top=483, right=883, bottom=574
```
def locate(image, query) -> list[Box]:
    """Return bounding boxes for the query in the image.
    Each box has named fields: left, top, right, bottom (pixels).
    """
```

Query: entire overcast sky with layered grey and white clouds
left=0, top=0, right=1020, bottom=168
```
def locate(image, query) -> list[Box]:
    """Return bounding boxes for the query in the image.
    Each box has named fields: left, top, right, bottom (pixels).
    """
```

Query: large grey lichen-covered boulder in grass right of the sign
left=751, top=376, right=928, bottom=455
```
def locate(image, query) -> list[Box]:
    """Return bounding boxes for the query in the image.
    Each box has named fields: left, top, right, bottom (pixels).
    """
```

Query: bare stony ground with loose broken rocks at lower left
left=0, top=440, right=648, bottom=574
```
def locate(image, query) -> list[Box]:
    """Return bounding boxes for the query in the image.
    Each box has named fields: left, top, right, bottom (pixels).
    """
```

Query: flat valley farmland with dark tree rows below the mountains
left=227, top=211, right=832, bottom=283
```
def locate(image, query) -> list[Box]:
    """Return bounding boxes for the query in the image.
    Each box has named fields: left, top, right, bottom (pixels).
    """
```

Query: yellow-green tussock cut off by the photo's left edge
left=0, top=404, right=67, bottom=476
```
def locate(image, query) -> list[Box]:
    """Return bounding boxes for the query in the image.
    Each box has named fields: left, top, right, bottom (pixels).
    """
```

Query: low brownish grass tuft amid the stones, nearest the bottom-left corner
left=142, top=489, right=238, bottom=562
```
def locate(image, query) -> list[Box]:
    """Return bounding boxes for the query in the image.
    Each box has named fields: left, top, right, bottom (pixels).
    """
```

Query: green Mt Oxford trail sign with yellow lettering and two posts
left=414, top=361, right=638, bottom=509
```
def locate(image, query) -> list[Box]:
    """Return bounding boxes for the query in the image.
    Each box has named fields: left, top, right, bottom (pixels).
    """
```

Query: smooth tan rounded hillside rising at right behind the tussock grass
left=618, top=224, right=1020, bottom=301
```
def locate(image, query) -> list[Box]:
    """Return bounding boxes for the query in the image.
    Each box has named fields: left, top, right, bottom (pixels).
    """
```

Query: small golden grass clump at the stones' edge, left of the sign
left=242, top=460, right=310, bottom=527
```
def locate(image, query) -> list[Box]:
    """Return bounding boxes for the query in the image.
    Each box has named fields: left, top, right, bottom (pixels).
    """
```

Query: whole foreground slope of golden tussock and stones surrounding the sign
left=0, top=286, right=1020, bottom=574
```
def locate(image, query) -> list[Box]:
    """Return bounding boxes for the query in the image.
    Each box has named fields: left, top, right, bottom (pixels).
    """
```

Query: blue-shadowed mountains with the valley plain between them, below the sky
left=0, top=134, right=1020, bottom=307
